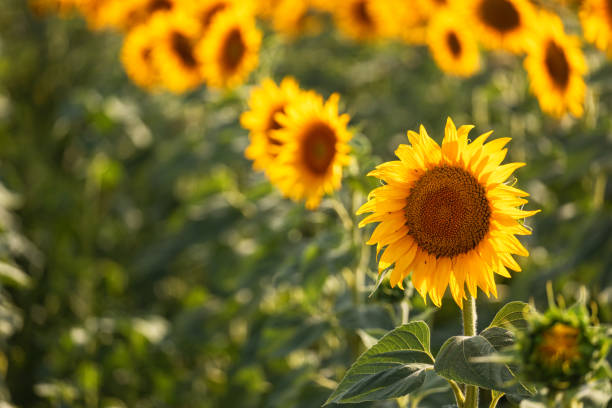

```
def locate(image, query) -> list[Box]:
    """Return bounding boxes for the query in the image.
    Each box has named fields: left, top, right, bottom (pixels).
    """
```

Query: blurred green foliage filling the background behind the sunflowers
left=0, top=0, right=612, bottom=408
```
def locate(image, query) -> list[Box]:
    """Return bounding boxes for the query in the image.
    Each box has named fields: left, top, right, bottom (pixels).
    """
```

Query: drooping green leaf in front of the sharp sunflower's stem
left=435, top=333, right=530, bottom=395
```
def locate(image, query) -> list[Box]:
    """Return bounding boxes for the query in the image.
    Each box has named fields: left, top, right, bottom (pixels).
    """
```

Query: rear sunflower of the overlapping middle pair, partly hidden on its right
left=240, top=77, right=303, bottom=170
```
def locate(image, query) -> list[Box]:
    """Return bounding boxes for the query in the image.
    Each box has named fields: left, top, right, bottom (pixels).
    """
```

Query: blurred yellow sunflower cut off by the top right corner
left=579, top=0, right=612, bottom=52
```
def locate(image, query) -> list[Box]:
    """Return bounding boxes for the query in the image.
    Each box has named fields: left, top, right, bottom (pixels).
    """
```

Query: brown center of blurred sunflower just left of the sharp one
left=301, top=122, right=336, bottom=175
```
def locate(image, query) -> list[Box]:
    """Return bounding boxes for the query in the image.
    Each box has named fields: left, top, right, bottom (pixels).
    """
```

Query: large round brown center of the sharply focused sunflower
left=405, top=166, right=491, bottom=258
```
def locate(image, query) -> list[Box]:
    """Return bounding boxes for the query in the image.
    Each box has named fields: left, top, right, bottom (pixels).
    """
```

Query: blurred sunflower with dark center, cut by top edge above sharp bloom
left=467, top=0, right=535, bottom=53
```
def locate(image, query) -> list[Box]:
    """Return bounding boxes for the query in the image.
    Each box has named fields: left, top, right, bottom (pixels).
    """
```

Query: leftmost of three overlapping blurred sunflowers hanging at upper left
left=121, top=24, right=159, bottom=89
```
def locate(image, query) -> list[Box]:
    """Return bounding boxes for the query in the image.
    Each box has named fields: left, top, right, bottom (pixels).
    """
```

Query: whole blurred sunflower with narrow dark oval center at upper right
left=525, top=11, right=587, bottom=117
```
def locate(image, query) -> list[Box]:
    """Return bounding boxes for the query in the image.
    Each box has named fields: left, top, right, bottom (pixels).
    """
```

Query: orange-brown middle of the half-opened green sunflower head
left=538, top=323, right=580, bottom=366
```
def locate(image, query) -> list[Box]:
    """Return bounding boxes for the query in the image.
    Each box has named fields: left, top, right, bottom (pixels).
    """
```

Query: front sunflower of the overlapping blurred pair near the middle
left=268, top=92, right=352, bottom=209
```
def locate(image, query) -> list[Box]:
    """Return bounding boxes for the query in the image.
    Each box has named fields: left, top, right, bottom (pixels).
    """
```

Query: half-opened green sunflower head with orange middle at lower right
left=517, top=305, right=609, bottom=389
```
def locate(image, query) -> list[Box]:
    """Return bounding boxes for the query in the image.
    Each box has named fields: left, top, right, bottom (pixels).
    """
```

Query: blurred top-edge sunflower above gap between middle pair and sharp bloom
left=334, top=0, right=388, bottom=41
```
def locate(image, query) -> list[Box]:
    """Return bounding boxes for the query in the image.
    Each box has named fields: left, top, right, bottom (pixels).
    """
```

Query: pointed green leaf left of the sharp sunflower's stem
left=326, top=322, right=435, bottom=404
